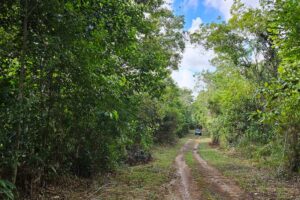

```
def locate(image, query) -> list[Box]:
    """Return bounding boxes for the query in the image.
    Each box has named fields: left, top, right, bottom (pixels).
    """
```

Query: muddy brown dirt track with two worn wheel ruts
left=168, top=138, right=249, bottom=200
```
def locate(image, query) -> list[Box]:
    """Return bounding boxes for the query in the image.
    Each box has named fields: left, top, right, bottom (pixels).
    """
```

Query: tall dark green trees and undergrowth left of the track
left=0, top=0, right=195, bottom=198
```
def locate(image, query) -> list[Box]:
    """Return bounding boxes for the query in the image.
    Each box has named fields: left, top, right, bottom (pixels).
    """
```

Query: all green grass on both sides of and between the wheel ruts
left=93, top=135, right=300, bottom=200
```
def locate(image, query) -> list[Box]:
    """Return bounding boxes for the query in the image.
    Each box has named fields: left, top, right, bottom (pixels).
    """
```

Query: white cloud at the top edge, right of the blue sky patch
left=204, top=0, right=259, bottom=21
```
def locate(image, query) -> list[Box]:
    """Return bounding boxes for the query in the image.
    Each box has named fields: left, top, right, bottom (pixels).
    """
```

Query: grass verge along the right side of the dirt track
left=199, top=137, right=300, bottom=199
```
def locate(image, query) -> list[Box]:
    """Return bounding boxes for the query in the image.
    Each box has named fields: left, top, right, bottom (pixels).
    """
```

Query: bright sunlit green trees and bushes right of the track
left=193, top=0, right=300, bottom=174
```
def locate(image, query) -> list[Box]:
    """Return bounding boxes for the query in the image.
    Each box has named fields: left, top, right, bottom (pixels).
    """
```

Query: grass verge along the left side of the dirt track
left=97, top=138, right=188, bottom=200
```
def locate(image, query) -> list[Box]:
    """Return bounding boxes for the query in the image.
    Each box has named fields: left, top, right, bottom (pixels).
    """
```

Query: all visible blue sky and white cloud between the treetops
left=169, top=0, right=259, bottom=95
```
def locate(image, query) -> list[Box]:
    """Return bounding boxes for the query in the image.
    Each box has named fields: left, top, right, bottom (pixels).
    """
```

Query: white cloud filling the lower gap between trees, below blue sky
left=172, top=17, right=214, bottom=96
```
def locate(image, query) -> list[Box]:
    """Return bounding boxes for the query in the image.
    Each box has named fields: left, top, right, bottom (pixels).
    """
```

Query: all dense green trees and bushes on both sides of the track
left=0, top=0, right=300, bottom=199
